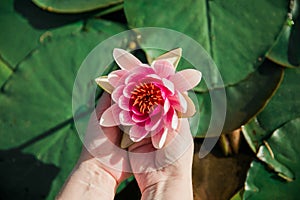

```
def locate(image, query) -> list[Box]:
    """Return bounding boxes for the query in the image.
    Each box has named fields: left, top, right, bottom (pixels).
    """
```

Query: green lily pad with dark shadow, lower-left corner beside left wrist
left=0, top=123, right=81, bottom=200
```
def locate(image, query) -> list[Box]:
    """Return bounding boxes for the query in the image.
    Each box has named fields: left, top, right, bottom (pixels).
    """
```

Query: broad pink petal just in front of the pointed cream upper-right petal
left=152, top=60, right=175, bottom=78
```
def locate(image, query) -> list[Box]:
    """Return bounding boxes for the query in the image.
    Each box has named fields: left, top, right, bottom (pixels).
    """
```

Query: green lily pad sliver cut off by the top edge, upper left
left=32, top=0, right=123, bottom=13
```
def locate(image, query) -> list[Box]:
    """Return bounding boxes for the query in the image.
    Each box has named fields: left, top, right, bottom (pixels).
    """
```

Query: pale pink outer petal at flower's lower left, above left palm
left=100, top=104, right=121, bottom=127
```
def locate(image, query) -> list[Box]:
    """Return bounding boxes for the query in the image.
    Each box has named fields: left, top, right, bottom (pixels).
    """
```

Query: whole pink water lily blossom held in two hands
left=95, top=48, right=202, bottom=149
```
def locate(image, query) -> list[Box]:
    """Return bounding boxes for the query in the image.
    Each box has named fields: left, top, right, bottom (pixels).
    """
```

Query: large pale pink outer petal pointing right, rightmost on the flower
left=169, top=69, right=202, bottom=92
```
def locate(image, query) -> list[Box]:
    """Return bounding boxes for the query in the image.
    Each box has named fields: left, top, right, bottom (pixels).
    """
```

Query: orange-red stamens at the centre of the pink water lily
left=131, top=83, right=163, bottom=114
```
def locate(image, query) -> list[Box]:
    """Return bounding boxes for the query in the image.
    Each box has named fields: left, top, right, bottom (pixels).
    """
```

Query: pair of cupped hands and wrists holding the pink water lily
left=58, top=94, right=193, bottom=199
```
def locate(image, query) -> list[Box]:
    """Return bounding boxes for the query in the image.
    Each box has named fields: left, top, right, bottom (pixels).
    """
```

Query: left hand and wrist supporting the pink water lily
left=57, top=93, right=131, bottom=200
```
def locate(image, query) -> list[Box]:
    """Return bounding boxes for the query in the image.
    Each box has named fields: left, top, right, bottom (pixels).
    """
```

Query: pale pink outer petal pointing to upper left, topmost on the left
left=113, top=48, right=142, bottom=71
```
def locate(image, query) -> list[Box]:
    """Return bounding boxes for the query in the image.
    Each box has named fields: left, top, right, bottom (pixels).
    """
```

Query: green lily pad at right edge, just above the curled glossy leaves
left=243, top=66, right=300, bottom=152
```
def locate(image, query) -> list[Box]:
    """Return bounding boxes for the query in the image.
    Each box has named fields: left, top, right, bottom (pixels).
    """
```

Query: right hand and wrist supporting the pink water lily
left=129, top=119, right=194, bottom=199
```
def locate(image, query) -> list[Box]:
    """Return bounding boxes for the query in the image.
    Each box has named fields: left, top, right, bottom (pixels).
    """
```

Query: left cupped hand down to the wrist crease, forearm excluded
left=79, top=93, right=131, bottom=184
